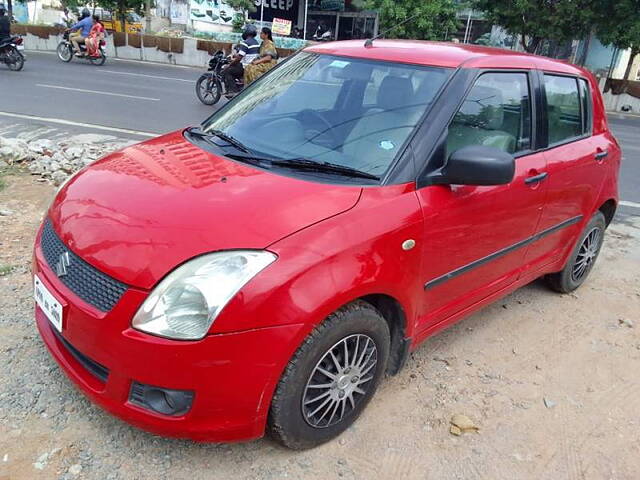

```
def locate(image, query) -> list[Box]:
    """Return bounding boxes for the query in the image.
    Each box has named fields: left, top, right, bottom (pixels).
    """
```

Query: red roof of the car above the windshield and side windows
left=305, top=40, right=589, bottom=76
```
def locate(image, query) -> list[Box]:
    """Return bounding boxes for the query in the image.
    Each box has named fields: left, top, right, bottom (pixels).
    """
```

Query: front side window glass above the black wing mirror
left=447, top=73, right=531, bottom=156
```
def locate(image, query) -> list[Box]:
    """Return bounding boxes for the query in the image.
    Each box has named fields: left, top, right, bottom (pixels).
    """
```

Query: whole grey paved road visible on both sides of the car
left=0, top=52, right=640, bottom=215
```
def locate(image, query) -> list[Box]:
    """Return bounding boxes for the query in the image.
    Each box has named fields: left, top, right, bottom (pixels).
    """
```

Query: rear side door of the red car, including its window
left=527, top=72, right=609, bottom=270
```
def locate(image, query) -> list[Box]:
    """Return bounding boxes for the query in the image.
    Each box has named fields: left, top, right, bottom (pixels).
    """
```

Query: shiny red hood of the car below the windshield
left=49, top=132, right=361, bottom=289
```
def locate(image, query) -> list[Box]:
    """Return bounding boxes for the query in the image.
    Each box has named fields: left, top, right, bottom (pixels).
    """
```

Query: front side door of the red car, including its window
left=417, top=72, right=546, bottom=330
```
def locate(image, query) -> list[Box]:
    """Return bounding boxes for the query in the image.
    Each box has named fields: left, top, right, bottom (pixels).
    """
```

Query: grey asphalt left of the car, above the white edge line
left=0, top=52, right=218, bottom=133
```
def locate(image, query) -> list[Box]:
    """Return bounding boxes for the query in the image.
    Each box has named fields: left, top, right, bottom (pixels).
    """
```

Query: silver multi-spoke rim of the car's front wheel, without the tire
left=302, top=334, right=378, bottom=428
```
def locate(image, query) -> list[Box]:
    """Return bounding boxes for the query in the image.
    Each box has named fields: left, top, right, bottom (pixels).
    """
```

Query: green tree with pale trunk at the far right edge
left=595, top=0, right=640, bottom=81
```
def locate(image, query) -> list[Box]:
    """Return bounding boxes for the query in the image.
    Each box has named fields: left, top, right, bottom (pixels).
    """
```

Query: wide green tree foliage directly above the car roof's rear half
left=472, top=0, right=599, bottom=53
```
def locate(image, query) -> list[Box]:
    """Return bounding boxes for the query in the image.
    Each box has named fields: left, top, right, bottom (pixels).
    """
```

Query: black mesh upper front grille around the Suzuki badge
left=40, top=219, right=127, bottom=312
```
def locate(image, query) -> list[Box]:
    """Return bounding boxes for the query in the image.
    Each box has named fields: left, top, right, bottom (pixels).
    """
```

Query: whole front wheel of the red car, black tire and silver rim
left=267, top=301, right=390, bottom=450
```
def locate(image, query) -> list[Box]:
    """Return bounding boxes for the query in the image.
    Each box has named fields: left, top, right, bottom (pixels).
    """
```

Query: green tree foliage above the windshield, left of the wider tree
left=365, top=0, right=458, bottom=40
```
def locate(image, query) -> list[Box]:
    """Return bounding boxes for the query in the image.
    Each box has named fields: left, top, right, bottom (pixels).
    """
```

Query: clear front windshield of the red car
left=202, top=52, right=451, bottom=177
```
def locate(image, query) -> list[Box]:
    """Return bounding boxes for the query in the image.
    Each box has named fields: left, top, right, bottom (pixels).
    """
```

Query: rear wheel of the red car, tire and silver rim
left=545, top=212, right=607, bottom=293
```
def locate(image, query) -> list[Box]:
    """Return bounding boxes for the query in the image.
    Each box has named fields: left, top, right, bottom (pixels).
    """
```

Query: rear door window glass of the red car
left=544, top=74, right=586, bottom=145
